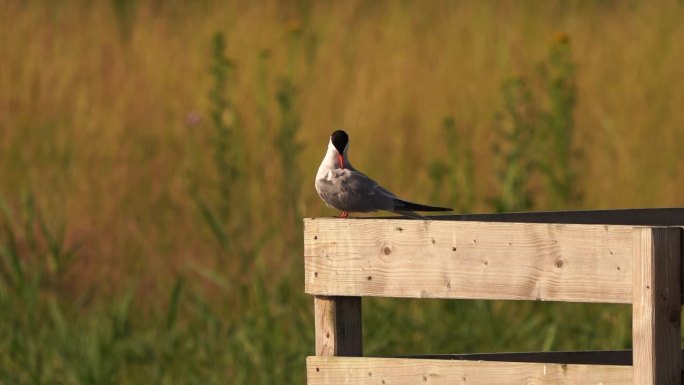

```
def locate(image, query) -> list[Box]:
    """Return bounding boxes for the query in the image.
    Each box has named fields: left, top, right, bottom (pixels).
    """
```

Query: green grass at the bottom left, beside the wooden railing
left=0, top=190, right=313, bottom=384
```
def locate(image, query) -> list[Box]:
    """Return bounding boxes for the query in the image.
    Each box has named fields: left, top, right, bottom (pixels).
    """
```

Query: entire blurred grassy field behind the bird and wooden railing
left=0, top=0, right=684, bottom=384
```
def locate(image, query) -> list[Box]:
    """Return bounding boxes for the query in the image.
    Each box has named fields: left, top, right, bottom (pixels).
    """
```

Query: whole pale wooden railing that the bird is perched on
left=304, top=209, right=684, bottom=385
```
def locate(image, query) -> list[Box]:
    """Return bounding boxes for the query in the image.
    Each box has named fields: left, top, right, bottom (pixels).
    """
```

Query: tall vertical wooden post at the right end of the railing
left=632, top=227, right=682, bottom=385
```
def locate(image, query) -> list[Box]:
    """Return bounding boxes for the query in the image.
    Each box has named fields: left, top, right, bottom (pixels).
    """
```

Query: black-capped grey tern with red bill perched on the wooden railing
left=316, top=130, right=451, bottom=219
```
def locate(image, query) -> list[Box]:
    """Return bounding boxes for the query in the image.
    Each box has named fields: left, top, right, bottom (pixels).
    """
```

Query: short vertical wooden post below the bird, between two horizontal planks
left=314, top=296, right=363, bottom=357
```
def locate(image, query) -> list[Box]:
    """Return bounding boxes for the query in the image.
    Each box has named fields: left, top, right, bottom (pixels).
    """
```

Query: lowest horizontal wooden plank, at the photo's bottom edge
left=306, top=357, right=633, bottom=385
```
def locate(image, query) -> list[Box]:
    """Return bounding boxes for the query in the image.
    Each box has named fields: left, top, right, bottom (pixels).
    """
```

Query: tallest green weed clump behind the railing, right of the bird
left=493, top=33, right=580, bottom=212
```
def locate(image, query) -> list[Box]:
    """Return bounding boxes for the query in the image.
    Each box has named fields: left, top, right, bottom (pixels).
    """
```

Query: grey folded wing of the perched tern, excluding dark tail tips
left=316, top=169, right=395, bottom=212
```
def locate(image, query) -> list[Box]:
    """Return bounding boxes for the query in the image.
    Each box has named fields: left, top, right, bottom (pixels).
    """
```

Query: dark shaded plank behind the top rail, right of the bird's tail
left=432, top=208, right=684, bottom=226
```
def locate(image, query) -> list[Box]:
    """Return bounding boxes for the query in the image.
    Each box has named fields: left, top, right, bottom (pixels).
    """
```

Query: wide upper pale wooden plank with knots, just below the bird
left=304, top=218, right=634, bottom=303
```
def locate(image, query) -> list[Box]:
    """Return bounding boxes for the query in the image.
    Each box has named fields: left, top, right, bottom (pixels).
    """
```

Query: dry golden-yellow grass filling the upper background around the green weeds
left=0, top=0, right=684, bottom=294
